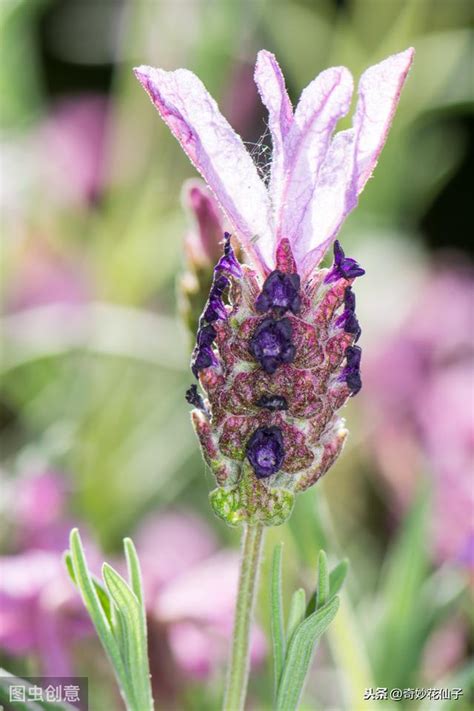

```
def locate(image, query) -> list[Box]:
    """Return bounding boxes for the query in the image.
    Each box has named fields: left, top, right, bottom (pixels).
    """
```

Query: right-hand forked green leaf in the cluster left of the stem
left=102, top=560, right=153, bottom=711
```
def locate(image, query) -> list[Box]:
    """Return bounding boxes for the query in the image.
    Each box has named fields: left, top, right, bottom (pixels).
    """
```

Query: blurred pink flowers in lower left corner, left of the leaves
left=0, top=471, right=95, bottom=676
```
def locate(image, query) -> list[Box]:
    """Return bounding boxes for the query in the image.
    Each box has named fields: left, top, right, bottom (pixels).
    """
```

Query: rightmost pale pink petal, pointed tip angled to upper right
left=353, top=48, right=415, bottom=193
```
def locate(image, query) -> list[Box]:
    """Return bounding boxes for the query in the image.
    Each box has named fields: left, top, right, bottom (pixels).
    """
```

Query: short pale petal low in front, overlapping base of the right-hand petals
left=298, top=128, right=357, bottom=277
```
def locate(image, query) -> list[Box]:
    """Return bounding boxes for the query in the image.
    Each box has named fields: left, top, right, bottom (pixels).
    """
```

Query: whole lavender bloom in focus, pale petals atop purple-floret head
left=135, top=49, right=414, bottom=525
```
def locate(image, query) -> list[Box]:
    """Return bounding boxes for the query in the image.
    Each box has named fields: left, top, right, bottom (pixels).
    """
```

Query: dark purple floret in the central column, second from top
left=249, top=318, right=296, bottom=373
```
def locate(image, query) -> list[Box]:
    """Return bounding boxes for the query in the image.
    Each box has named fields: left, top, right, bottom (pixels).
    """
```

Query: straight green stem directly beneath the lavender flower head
left=223, top=525, right=263, bottom=711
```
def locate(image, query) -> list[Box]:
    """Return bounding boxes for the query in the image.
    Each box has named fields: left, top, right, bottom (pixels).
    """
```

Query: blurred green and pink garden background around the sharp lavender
left=0, top=0, right=474, bottom=711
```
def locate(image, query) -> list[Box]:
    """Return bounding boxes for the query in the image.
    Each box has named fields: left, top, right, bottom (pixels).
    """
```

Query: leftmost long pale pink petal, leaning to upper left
left=135, top=66, right=274, bottom=271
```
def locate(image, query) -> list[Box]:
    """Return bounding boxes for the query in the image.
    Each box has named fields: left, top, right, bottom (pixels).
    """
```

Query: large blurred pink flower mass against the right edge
left=365, top=268, right=474, bottom=568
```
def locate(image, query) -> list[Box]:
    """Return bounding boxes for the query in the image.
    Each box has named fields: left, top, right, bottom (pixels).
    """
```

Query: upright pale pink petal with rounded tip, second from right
left=277, top=67, right=353, bottom=249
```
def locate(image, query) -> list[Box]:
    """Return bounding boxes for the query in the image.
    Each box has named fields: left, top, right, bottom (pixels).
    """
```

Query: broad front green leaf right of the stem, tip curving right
left=276, top=597, right=339, bottom=711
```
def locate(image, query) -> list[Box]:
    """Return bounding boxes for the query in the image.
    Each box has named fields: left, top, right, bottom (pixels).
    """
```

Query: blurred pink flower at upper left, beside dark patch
left=39, top=94, right=108, bottom=205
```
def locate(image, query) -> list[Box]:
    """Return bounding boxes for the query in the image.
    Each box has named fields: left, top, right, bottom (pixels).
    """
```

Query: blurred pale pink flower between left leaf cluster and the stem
left=135, top=513, right=266, bottom=683
